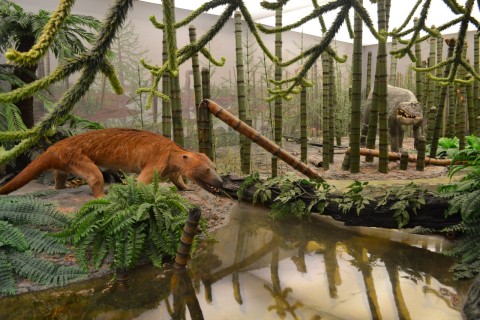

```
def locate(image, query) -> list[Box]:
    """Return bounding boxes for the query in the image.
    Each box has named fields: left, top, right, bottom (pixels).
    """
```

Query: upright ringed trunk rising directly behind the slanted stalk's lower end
left=322, top=53, right=331, bottom=170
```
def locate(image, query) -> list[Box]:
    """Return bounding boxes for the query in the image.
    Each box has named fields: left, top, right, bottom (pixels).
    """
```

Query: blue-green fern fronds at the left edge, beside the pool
left=0, top=195, right=86, bottom=295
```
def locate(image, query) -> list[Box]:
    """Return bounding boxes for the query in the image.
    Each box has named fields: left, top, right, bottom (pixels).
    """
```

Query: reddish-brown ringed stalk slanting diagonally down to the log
left=201, top=100, right=324, bottom=181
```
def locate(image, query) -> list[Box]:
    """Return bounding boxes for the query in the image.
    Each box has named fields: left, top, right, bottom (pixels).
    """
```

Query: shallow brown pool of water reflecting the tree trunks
left=0, top=206, right=469, bottom=320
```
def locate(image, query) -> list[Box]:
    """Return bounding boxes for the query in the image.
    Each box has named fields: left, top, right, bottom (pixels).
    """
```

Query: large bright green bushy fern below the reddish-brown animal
left=58, top=175, right=197, bottom=270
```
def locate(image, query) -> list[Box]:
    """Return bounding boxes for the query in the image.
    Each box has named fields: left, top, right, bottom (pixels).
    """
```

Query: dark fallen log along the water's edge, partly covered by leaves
left=222, top=175, right=461, bottom=230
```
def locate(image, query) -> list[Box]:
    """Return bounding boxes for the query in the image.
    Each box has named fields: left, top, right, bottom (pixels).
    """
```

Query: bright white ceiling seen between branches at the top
left=141, top=0, right=480, bottom=45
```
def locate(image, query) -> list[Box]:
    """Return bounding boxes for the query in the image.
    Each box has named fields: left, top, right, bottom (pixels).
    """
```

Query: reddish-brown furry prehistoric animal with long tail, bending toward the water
left=0, top=128, right=223, bottom=198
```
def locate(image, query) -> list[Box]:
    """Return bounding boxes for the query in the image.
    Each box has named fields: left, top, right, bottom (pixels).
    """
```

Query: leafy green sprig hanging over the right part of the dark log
left=377, top=182, right=426, bottom=228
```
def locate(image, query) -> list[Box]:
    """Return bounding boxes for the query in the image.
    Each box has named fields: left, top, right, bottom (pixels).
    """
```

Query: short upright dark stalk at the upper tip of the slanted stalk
left=197, top=67, right=215, bottom=161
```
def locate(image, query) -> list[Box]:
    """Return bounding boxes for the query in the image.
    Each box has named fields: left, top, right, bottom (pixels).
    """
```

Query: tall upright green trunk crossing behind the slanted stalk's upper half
left=235, top=12, right=250, bottom=174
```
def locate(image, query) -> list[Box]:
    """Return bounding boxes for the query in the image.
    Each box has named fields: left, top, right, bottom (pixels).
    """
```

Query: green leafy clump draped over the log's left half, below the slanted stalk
left=253, top=173, right=330, bottom=219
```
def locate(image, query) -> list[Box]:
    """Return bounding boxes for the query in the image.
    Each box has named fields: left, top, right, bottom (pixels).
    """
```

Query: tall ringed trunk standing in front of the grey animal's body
left=374, top=0, right=390, bottom=173
